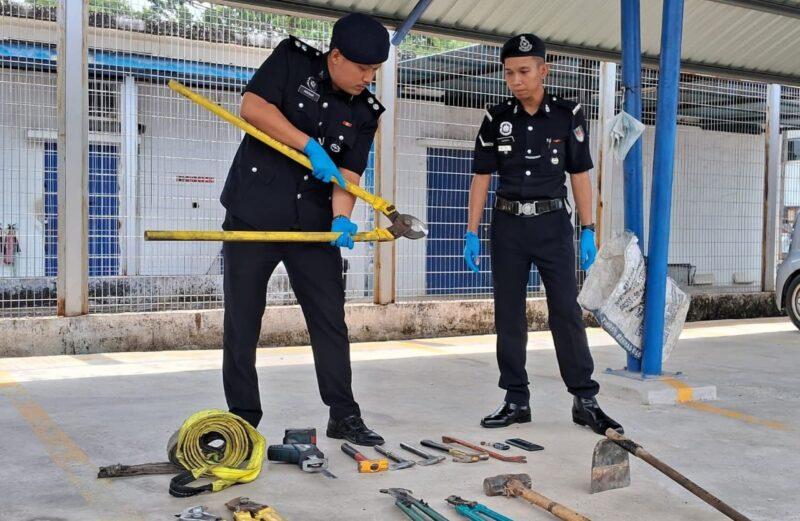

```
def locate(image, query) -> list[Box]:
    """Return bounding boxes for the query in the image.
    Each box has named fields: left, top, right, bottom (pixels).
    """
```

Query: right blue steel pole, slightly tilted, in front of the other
left=642, top=0, right=683, bottom=376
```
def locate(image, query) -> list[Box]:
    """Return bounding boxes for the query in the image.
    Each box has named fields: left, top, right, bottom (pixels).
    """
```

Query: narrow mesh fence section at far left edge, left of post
left=0, top=0, right=58, bottom=316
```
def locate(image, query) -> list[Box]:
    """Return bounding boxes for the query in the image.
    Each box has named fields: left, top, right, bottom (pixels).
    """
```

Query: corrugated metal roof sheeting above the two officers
left=245, top=0, right=800, bottom=84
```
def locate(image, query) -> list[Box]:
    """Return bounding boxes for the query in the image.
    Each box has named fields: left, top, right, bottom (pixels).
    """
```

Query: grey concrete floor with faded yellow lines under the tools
left=0, top=319, right=800, bottom=521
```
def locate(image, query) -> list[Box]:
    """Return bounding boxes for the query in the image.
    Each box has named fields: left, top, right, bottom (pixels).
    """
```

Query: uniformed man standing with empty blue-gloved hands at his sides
left=464, top=34, right=622, bottom=434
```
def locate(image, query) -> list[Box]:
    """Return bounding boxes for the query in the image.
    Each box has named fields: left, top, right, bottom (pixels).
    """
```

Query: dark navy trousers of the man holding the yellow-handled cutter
left=222, top=214, right=360, bottom=426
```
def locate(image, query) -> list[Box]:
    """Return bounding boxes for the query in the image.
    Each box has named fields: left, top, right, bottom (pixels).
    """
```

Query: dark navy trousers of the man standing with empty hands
left=491, top=209, right=599, bottom=405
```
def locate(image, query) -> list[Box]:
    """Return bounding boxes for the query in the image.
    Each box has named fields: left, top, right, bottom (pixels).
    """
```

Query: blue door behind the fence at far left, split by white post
left=44, top=143, right=119, bottom=277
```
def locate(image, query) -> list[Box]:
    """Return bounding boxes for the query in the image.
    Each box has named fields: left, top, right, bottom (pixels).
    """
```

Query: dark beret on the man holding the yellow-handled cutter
left=330, top=13, right=389, bottom=65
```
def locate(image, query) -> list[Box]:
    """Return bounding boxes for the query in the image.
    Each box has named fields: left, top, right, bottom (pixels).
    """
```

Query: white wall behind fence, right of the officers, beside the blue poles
left=611, top=126, right=764, bottom=286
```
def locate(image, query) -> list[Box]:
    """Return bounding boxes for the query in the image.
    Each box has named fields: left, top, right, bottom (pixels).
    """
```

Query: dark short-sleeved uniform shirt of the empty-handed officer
left=473, top=92, right=593, bottom=201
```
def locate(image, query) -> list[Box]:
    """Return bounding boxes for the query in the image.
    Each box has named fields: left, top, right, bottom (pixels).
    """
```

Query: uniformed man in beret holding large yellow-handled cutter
left=220, top=14, right=389, bottom=446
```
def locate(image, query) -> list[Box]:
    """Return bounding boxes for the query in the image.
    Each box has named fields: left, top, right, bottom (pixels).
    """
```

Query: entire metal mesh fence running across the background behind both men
left=0, top=0, right=800, bottom=317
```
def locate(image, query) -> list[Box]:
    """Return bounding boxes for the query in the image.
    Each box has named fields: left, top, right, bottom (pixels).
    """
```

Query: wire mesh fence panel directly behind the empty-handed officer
left=396, top=33, right=599, bottom=299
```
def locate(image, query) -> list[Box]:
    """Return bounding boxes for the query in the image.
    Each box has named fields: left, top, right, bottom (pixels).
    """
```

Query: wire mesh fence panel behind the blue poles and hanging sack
left=611, top=69, right=767, bottom=293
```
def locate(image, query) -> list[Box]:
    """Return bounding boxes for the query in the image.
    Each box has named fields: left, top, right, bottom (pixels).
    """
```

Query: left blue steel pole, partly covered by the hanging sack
left=621, top=0, right=644, bottom=373
